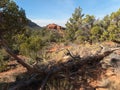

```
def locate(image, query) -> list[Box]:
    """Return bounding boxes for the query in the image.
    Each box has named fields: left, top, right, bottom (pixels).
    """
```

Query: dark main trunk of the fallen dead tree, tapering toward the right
left=44, top=49, right=116, bottom=73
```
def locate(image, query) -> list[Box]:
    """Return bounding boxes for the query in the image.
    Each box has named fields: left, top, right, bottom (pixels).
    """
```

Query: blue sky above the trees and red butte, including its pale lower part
left=15, top=0, right=120, bottom=26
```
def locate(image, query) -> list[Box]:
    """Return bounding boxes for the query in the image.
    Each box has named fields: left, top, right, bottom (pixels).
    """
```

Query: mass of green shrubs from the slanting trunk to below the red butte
left=12, top=29, right=62, bottom=60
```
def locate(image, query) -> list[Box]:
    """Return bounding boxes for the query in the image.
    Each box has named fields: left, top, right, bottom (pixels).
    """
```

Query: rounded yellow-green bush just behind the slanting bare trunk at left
left=14, top=31, right=43, bottom=59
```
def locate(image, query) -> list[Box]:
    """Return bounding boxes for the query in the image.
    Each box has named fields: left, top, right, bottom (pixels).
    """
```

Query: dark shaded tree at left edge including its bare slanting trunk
left=0, top=0, right=33, bottom=71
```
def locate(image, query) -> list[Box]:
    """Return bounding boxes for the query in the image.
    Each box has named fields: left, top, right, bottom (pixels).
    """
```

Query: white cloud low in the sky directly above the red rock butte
left=32, top=19, right=67, bottom=26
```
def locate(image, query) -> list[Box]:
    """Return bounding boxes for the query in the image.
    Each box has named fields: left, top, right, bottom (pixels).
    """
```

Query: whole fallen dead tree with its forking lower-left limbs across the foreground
left=9, top=49, right=118, bottom=90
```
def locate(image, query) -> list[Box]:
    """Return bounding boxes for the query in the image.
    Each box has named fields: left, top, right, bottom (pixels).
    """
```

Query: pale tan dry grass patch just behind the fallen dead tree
left=49, top=44, right=100, bottom=62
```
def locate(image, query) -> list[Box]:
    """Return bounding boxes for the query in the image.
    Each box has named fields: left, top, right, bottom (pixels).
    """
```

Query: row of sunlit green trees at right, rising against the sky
left=65, top=7, right=120, bottom=42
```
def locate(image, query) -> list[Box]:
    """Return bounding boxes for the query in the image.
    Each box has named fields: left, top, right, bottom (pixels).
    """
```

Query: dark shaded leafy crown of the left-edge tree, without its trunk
left=0, top=0, right=27, bottom=37
